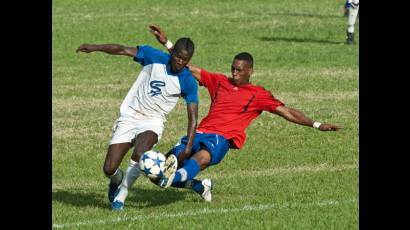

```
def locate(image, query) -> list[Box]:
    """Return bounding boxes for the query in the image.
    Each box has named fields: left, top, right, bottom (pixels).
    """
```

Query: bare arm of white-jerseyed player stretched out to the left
left=76, top=44, right=138, bottom=57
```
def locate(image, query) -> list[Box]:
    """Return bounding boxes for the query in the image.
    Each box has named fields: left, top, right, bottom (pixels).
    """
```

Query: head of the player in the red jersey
left=231, top=52, right=253, bottom=85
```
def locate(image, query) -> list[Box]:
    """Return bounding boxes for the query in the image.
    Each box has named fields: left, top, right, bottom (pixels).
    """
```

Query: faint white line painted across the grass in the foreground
left=53, top=198, right=358, bottom=228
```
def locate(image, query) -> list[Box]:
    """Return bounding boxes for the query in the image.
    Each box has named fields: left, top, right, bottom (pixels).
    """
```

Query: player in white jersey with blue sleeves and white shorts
left=76, top=38, right=198, bottom=210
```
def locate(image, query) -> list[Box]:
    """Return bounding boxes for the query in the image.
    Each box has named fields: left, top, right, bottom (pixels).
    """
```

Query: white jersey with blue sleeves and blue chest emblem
left=120, top=46, right=198, bottom=121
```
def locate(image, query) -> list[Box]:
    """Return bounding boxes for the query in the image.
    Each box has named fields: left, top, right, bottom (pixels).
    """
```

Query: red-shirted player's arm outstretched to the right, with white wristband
left=274, top=106, right=341, bottom=131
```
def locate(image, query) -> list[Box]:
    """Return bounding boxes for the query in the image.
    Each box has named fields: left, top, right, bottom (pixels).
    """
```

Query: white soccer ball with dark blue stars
left=140, top=150, right=165, bottom=179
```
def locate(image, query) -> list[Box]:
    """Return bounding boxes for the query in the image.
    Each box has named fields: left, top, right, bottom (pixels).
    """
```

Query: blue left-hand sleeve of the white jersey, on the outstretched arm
left=134, top=45, right=170, bottom=66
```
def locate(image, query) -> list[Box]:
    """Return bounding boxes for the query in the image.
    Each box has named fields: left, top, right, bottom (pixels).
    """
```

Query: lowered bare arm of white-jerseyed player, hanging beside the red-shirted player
left=178, top=103, right=198, bottom=162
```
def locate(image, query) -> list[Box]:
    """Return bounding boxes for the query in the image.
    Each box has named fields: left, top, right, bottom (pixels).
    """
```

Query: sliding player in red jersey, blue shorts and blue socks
left=150, top=26, right=340, bottom=201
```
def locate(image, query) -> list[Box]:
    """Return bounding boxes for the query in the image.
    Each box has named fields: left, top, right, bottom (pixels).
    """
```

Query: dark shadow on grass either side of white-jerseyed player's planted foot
left=52, top=187, right=188, bottom=209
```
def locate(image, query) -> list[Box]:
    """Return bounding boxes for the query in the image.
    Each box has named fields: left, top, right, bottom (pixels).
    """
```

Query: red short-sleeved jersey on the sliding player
left=197, top=69, right=284, bottom=149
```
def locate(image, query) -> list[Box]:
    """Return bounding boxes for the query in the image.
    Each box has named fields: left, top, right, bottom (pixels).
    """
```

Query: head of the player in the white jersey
left=171, top=38, right=195, bottom=73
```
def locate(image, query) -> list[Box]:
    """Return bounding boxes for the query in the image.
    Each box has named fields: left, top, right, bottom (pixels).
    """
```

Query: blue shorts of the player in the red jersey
left=170, top=133, right=229, bottom=167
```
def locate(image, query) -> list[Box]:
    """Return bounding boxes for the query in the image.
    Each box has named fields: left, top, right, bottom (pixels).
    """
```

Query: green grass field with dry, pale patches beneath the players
left=52, top=0, right=359, bottom=230
